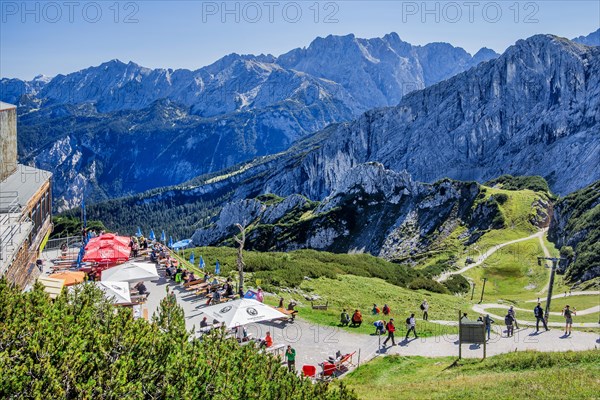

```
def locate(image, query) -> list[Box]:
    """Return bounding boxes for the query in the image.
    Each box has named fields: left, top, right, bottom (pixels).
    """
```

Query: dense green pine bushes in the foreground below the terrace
left=0, top=280, right=356, bottom=400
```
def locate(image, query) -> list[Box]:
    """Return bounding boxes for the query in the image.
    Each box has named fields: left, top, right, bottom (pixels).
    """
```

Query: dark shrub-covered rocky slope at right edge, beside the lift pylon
left=548, top=181, right=600, bottom=281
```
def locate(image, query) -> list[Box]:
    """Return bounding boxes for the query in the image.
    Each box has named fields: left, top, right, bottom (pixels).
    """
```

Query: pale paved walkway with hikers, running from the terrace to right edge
left=146, top=278, right=600, bottom=370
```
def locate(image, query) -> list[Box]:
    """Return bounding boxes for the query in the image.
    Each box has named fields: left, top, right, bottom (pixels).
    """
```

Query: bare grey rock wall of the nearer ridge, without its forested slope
left=278, top=35, right=600, bottom=198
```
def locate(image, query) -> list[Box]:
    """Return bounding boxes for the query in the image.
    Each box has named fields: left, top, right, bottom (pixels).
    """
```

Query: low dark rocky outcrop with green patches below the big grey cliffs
left=192, top=163, right=502, bottom=260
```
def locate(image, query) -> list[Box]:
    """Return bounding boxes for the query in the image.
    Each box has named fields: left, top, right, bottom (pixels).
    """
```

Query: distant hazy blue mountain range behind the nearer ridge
left=0, top=33, right=498, bottom=210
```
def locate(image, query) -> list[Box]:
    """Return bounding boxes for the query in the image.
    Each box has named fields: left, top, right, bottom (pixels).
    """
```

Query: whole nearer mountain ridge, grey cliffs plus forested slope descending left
left=85, top=35, right=600, bottom=244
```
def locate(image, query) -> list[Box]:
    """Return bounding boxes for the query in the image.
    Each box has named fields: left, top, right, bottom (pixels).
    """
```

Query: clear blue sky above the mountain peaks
left=0, top=0, right=600, bottom=79
